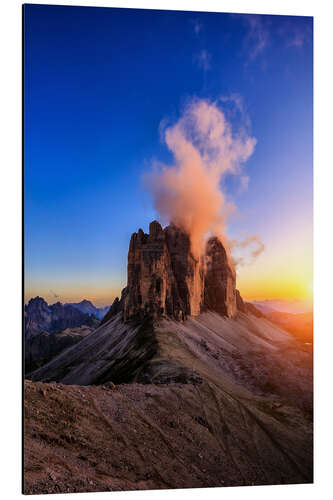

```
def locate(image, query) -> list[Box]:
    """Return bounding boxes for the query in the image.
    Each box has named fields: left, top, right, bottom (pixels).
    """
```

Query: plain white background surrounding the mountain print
left=0, top=0, right=333, bottom=500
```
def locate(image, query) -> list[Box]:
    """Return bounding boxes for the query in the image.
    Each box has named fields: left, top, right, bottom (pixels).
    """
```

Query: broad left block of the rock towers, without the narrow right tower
left=124, top=221, right=203, bottom=320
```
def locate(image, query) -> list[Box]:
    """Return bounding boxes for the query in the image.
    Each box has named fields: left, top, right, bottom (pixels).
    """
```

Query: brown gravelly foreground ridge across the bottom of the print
left=24, top=381, right=312, bottom=494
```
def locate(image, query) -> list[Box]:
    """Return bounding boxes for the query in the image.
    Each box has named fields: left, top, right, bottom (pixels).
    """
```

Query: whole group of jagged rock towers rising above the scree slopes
left=103, top=221, right=237, bottom=322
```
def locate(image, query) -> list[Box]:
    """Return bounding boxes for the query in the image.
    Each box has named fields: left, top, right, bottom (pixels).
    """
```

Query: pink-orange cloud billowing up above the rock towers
left=145, top=99, right=256, bottom=257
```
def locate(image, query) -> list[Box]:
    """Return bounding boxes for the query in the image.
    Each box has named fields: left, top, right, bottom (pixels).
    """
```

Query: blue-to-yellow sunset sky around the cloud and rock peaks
left=24, top=5, right=313, bottom=305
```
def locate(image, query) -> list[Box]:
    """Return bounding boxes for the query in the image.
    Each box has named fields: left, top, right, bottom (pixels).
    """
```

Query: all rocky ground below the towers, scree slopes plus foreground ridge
left=24, top=312, right=312, bottom=493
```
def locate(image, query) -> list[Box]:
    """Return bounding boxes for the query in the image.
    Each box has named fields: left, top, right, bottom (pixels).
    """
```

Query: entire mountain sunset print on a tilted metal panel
left=22, top=4, right=313, bottom=494
